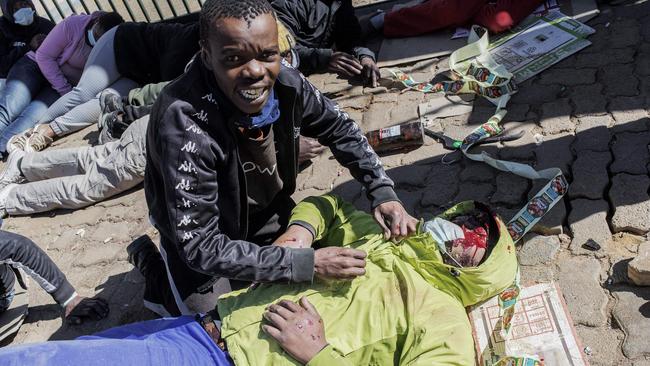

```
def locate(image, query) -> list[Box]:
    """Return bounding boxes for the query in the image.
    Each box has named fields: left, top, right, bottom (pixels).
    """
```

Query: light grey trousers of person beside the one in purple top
left=39, top=27, right=138, bottom=136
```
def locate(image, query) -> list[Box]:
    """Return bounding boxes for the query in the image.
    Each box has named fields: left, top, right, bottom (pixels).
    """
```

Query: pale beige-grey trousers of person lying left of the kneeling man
left=5, top=116, right=149, bottom=215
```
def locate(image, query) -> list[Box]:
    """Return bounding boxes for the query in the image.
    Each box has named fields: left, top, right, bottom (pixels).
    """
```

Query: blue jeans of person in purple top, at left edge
left=0, top=56, right=58, bottom=152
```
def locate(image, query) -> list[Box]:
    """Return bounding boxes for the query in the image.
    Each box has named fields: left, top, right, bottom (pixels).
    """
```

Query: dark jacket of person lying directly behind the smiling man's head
left=271, top=0, right=375, bottom=74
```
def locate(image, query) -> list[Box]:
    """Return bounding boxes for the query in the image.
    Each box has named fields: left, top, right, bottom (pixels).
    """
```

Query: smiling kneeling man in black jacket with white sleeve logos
left=140, top=0, right=417, bottom=315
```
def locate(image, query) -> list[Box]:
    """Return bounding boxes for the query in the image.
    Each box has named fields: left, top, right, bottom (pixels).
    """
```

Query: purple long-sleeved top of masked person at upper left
left=36, top=11, right=101, bottom=95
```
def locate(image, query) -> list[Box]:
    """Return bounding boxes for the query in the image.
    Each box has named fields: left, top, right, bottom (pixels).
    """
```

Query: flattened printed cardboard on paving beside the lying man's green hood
left=469, top=283, right=589, bottom=366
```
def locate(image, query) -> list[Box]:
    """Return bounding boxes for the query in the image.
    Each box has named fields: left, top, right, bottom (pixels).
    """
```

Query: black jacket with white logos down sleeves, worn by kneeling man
left=145, top=58, right=397, bottom=297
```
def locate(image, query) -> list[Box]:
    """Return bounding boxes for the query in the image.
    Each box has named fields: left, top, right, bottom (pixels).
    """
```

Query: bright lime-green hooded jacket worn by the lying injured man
left=218, top=196, right=517, bottom=366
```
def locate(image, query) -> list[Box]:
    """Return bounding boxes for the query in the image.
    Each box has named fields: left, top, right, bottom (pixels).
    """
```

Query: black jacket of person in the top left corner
left=0, top=0, right=54, bottom=78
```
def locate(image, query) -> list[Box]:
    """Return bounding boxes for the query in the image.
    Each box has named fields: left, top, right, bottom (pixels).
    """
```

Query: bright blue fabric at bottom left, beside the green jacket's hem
left=0, top=316, right=233, bottom=366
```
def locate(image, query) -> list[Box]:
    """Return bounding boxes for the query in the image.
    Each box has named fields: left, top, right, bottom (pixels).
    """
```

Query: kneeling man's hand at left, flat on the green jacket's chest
left=314, top=247, right=366, bottom=280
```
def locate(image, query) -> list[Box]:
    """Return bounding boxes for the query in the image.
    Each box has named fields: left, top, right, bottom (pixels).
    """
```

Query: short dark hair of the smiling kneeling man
left=199, top=0, right=275, bottom=40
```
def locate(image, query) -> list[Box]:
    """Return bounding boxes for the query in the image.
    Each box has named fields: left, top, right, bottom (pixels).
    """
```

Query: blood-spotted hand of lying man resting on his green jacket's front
left=262, top=297, right=327, bottom=365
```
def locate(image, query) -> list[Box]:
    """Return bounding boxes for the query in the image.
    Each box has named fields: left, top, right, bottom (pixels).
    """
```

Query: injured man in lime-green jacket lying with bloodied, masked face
left=0, top=196, right=517, bottom=365
